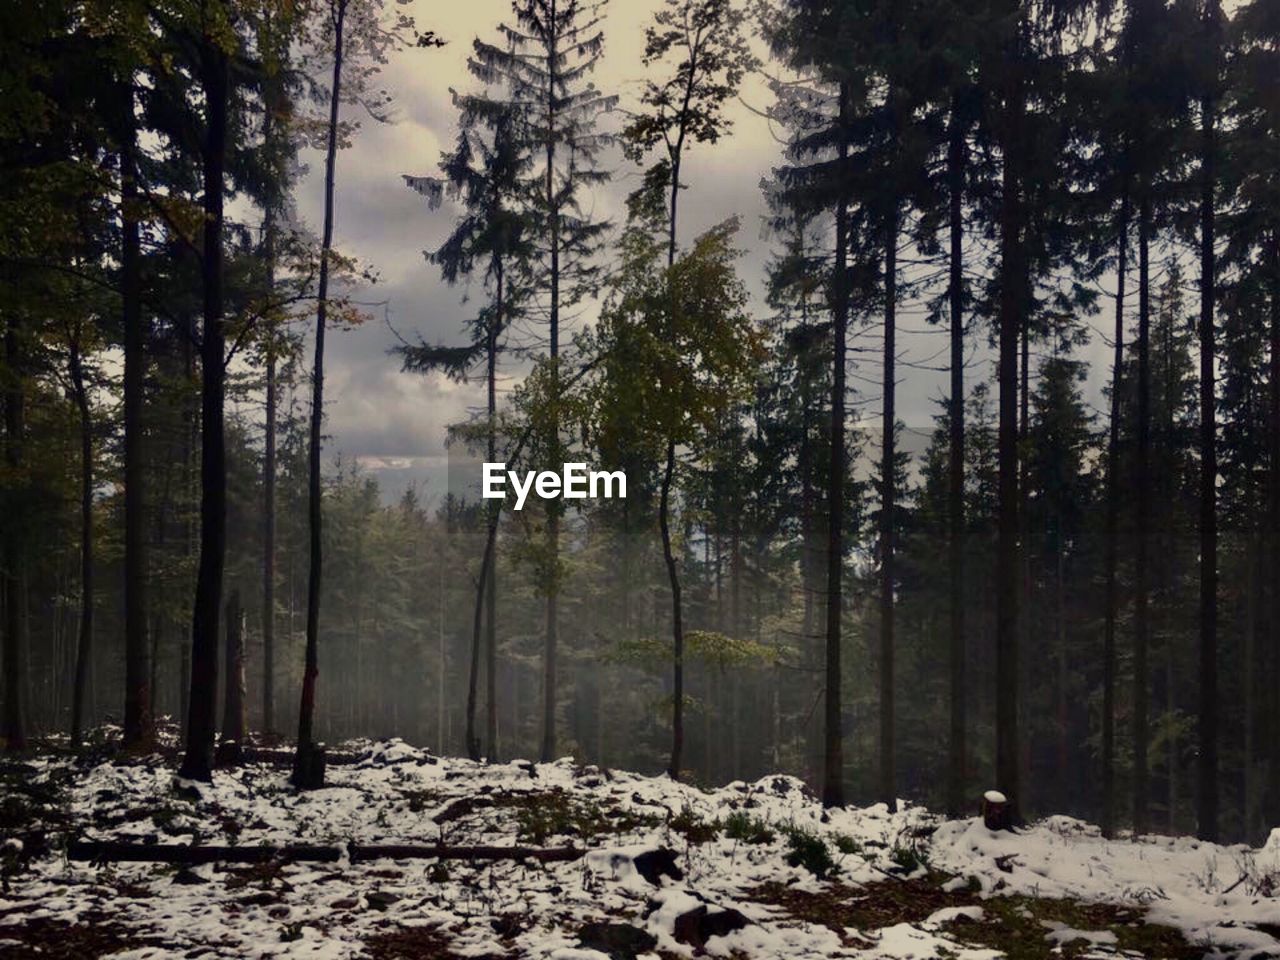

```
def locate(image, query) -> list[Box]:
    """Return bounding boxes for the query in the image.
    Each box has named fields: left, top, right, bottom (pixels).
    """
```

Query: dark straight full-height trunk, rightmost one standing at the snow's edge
left=1197, top=0, right=1221, bottom=841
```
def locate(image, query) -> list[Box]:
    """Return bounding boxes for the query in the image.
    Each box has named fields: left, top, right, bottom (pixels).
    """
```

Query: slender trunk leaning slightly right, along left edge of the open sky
left=293, top=0, right=348, bottom=790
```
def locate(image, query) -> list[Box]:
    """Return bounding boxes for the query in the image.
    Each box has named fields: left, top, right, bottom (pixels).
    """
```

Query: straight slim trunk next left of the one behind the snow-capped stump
left=947, top=95, right=968, bottom=817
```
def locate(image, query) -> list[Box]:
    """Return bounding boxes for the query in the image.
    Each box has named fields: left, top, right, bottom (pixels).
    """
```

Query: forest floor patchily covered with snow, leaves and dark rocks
left=0, top=740, right=1280, bottom=960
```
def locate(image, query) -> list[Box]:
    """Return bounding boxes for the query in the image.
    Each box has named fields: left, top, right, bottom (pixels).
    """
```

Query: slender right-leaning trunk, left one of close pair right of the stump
left=1102, top=183, right=1129, bottom=837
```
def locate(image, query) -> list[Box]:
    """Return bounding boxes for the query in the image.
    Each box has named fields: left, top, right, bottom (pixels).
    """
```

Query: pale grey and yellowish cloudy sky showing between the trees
left=288, top=0, right=1121, bottom=506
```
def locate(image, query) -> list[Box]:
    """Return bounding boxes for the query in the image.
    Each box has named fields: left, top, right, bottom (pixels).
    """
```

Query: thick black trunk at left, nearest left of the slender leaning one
left=179, top=36, right=229, bottom=781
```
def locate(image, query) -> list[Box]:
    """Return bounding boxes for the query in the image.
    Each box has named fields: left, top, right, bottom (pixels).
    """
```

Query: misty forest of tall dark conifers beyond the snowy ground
left=0, top=0, right=1280, bottom=901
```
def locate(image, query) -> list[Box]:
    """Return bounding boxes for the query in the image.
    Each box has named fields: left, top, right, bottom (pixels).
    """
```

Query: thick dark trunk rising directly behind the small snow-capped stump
left=996, top=52, right=1028, bottom=815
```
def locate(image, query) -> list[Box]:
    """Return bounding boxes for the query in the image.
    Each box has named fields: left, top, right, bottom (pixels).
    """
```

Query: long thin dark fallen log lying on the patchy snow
left=67, top=840, right=586, bottom=864
